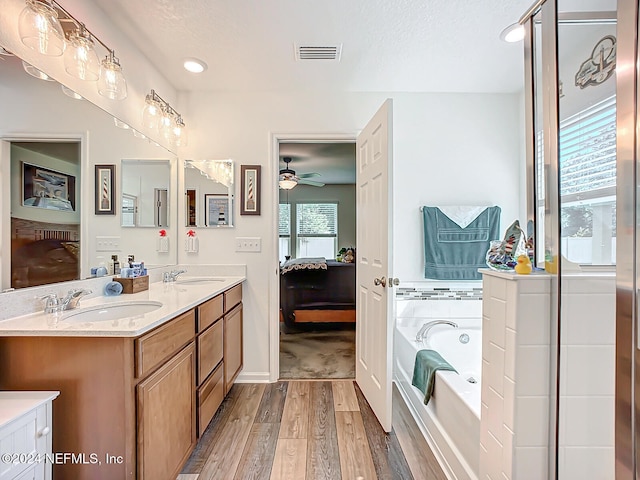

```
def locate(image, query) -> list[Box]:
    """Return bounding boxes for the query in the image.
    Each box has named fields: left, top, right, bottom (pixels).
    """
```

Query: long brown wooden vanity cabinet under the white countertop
left=0, top=285, right=242, bottom=480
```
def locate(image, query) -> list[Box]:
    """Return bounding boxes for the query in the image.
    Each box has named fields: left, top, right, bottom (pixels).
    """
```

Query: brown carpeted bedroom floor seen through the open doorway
left=280, top=330, right=356, bottom=379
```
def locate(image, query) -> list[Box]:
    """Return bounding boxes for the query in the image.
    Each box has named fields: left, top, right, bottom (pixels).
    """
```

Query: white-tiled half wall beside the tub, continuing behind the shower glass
left=480, top=270, right=615, bottom=480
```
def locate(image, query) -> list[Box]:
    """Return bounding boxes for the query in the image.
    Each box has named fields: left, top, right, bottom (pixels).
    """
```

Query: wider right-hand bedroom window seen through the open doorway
left=296, top=203, right=338, bottom=258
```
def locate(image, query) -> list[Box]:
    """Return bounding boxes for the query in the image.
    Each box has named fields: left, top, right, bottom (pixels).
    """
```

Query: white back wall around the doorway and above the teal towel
left=178, top=92, right=522, bottom=380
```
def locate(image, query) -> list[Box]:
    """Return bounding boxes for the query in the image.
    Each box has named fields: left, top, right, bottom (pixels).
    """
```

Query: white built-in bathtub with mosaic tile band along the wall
left=393, top=281, right=482, bottom=480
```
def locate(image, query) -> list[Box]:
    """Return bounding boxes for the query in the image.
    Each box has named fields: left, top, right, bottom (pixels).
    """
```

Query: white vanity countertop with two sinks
left=0, top=276, right=246, bottom=337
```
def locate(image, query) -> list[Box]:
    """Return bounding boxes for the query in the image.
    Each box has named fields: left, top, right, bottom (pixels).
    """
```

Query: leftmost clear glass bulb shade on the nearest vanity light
left=18, top=0, right=65, bottom=57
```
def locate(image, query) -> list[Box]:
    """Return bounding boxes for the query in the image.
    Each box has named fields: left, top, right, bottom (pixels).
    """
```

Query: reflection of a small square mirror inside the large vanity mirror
left=121, top=159, right=171, bottom=228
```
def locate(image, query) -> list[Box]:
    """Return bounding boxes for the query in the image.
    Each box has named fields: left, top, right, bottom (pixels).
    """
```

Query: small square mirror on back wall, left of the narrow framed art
left=184, top=159, right=234, bottom=227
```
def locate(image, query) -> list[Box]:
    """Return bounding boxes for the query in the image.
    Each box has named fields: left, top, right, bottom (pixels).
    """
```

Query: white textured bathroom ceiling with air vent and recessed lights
left=92, top=0, right=532, bottom=92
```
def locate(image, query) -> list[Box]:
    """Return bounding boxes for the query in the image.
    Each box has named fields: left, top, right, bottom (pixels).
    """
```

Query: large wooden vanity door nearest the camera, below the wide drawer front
left=136, top=342, right=196, bottom=480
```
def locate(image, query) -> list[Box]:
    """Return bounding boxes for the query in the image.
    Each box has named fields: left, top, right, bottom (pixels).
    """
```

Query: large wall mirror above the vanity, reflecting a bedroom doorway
left=0, top=56, right=178, bottom=291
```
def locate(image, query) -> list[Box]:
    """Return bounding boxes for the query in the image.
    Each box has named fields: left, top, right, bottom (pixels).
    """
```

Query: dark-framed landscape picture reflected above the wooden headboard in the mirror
left=22, top=162, right=76, bottom=212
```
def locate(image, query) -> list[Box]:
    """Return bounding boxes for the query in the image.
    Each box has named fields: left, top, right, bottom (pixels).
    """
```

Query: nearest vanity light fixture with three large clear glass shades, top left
left=18, top=0, right=127, bottom=100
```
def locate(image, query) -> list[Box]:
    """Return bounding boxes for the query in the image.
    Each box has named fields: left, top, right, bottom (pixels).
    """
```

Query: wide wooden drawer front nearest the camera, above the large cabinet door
left=135, top=310, right=195, bottom=378
